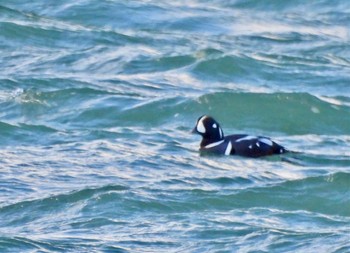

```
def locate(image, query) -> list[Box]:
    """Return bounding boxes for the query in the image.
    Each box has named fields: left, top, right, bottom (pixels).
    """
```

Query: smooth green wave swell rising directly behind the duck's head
left=113, top=92, right=349, bottom=135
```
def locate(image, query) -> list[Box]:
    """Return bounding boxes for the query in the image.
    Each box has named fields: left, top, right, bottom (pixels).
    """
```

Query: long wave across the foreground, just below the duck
left=0, top=172, right=350, bottom=226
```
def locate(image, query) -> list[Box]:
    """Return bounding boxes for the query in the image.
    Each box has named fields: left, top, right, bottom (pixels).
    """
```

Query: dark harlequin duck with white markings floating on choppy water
left=192, top=115, right=288, bottom=157
